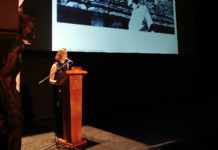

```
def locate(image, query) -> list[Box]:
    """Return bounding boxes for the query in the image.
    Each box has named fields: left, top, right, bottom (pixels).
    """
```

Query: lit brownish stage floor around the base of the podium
left=21, top=126, right=148, bottom=150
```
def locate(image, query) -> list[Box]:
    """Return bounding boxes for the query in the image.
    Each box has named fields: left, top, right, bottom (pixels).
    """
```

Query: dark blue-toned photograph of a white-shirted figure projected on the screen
left=57, top=0, right=175, bottom=34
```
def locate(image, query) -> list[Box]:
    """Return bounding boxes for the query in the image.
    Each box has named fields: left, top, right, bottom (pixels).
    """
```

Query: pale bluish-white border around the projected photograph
left=52, top=0, right=178, bottom=54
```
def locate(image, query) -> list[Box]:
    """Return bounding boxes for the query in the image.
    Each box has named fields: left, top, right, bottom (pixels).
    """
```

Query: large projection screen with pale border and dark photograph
left=52, top=0, right=178, bottom=54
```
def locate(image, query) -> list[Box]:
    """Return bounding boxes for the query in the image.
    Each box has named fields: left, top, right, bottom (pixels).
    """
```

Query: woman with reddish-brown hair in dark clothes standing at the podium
left=49, top=48, right=69, bottom=138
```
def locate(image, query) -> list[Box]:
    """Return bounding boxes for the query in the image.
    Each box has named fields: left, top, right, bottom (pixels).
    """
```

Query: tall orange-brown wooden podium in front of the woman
left=59, top=67, right=87, bottom=147
